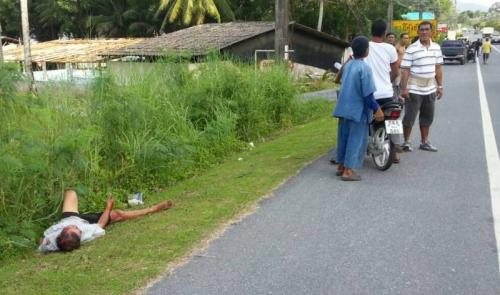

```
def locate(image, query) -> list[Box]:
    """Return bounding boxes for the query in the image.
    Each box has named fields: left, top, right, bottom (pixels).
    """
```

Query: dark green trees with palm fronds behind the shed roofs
left=0, top=0, right=457, bottom=41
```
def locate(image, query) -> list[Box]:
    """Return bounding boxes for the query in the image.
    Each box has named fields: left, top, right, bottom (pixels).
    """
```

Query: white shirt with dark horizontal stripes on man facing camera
left=401, top=40, right=443, bottom=95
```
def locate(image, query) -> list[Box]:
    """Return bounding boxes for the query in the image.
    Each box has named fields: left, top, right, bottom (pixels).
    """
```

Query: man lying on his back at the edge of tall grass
left=38, top=190, right=173, bottom=252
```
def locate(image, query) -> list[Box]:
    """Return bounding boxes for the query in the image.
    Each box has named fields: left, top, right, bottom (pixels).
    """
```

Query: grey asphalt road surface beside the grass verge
left=146, top=48, right=500, bottom=295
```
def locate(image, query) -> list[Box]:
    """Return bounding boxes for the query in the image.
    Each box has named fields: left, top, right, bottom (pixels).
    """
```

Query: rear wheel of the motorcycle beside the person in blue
left=372, top=125, right=396, bottom=171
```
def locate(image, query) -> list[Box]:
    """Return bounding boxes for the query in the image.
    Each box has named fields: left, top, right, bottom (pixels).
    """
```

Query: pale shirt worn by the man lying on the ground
left=38, top=216, right=105, bottom=252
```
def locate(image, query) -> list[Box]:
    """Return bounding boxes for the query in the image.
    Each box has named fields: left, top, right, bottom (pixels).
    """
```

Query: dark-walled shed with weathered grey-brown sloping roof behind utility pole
left=105, top=22, right=349, bottom=70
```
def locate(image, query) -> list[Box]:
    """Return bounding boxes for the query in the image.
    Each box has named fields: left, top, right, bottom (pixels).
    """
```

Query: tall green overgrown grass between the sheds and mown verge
left=0, top=57, right=324, bottom=257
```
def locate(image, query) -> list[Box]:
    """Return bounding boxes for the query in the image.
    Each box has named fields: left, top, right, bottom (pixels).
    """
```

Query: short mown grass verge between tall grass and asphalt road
left=0, top=114, right=336, bottom=294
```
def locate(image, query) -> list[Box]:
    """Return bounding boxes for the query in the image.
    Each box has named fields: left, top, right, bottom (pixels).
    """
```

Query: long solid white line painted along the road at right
left=476, top=57, right=500, bottom=269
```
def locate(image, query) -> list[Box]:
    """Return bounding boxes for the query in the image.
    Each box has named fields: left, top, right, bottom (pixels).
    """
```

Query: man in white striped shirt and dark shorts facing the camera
left=401, top=21, right=443, bottom=152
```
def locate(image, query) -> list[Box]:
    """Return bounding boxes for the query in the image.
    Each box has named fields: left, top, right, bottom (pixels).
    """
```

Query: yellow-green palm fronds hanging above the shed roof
left=157, top=0, right=234, bottom=31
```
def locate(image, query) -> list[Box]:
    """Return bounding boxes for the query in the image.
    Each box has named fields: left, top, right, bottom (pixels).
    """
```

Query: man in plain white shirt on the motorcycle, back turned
left=366, top=20, right=403, bottom=163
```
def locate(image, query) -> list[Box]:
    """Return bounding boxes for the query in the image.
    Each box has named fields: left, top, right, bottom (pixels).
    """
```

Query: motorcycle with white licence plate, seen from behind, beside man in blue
left=367, top=100, right=403, bottom=171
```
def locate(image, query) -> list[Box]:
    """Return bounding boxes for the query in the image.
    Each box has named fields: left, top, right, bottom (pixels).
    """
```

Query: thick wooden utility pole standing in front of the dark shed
left=274, top=0, right=289, bottom=61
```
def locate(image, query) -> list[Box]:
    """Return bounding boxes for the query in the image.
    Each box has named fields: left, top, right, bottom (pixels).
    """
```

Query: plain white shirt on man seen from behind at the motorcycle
left=366, top=41, right=398, bottom=99
